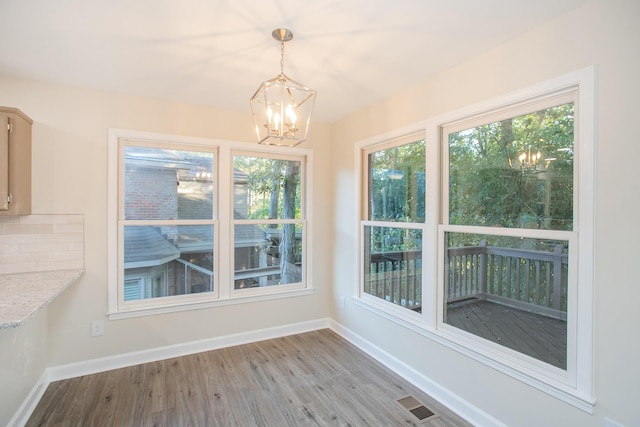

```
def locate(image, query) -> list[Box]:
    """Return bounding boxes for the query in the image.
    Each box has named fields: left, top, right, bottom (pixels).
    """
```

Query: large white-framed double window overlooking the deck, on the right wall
left=357, top=69, right=595, bottom=412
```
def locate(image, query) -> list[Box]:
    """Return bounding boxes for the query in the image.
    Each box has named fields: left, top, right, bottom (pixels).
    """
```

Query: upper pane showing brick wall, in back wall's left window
left=124, top=146, right=214, bottom=219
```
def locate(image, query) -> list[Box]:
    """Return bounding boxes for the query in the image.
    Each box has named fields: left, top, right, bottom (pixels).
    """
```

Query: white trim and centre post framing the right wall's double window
left=354, top=67, right=596, bottom=413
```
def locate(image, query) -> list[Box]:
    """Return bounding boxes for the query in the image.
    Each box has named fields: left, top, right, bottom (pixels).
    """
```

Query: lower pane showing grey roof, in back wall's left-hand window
left=124, top=225, right=214, bottom=301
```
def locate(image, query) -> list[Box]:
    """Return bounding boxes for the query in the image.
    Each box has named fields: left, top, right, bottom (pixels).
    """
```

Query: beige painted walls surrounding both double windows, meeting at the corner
left=0, top=0, right=640, bottom=426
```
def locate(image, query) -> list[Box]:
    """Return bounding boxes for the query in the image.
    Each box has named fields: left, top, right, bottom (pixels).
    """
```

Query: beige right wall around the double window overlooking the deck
left=332, top=0, right=640, bottom=426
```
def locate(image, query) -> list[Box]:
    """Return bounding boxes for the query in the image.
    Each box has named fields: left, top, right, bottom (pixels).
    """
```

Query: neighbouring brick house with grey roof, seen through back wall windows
left=124, top=147, right=290, bottom=300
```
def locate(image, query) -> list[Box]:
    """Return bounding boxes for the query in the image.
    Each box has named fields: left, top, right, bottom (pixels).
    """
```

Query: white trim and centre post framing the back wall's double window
left=107, top=128, right=313, bottom=320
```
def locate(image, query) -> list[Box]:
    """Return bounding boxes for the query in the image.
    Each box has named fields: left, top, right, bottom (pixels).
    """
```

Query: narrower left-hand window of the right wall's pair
left=361, top=134, right=426, bottom=313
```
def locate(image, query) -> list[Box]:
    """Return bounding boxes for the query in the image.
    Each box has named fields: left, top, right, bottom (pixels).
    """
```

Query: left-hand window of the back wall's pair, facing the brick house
left=110, top=138, right=217, bottom=310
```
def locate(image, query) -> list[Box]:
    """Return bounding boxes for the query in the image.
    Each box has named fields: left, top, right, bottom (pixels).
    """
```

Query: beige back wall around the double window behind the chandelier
left=0, top=73, right=331, bottom=372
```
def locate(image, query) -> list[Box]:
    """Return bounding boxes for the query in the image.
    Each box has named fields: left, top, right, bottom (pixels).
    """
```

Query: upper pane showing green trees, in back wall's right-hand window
left=233, top=156, right=302, bottom=219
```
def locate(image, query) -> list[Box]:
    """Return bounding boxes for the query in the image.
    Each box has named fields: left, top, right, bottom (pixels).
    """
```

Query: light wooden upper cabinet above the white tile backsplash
left=0, top=107, right=33, bottom=215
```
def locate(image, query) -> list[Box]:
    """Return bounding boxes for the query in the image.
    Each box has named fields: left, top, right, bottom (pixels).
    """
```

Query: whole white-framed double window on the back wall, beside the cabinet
left=109, top=130, right=310, bottom=319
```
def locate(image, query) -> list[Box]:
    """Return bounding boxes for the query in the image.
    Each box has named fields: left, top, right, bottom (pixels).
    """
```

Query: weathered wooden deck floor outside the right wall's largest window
left=446, top=299, right=567, bottom=369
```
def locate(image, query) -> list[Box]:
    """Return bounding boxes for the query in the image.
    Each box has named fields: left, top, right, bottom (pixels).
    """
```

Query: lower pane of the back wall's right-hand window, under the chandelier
left=234, top=224, right=303, bottom=289
